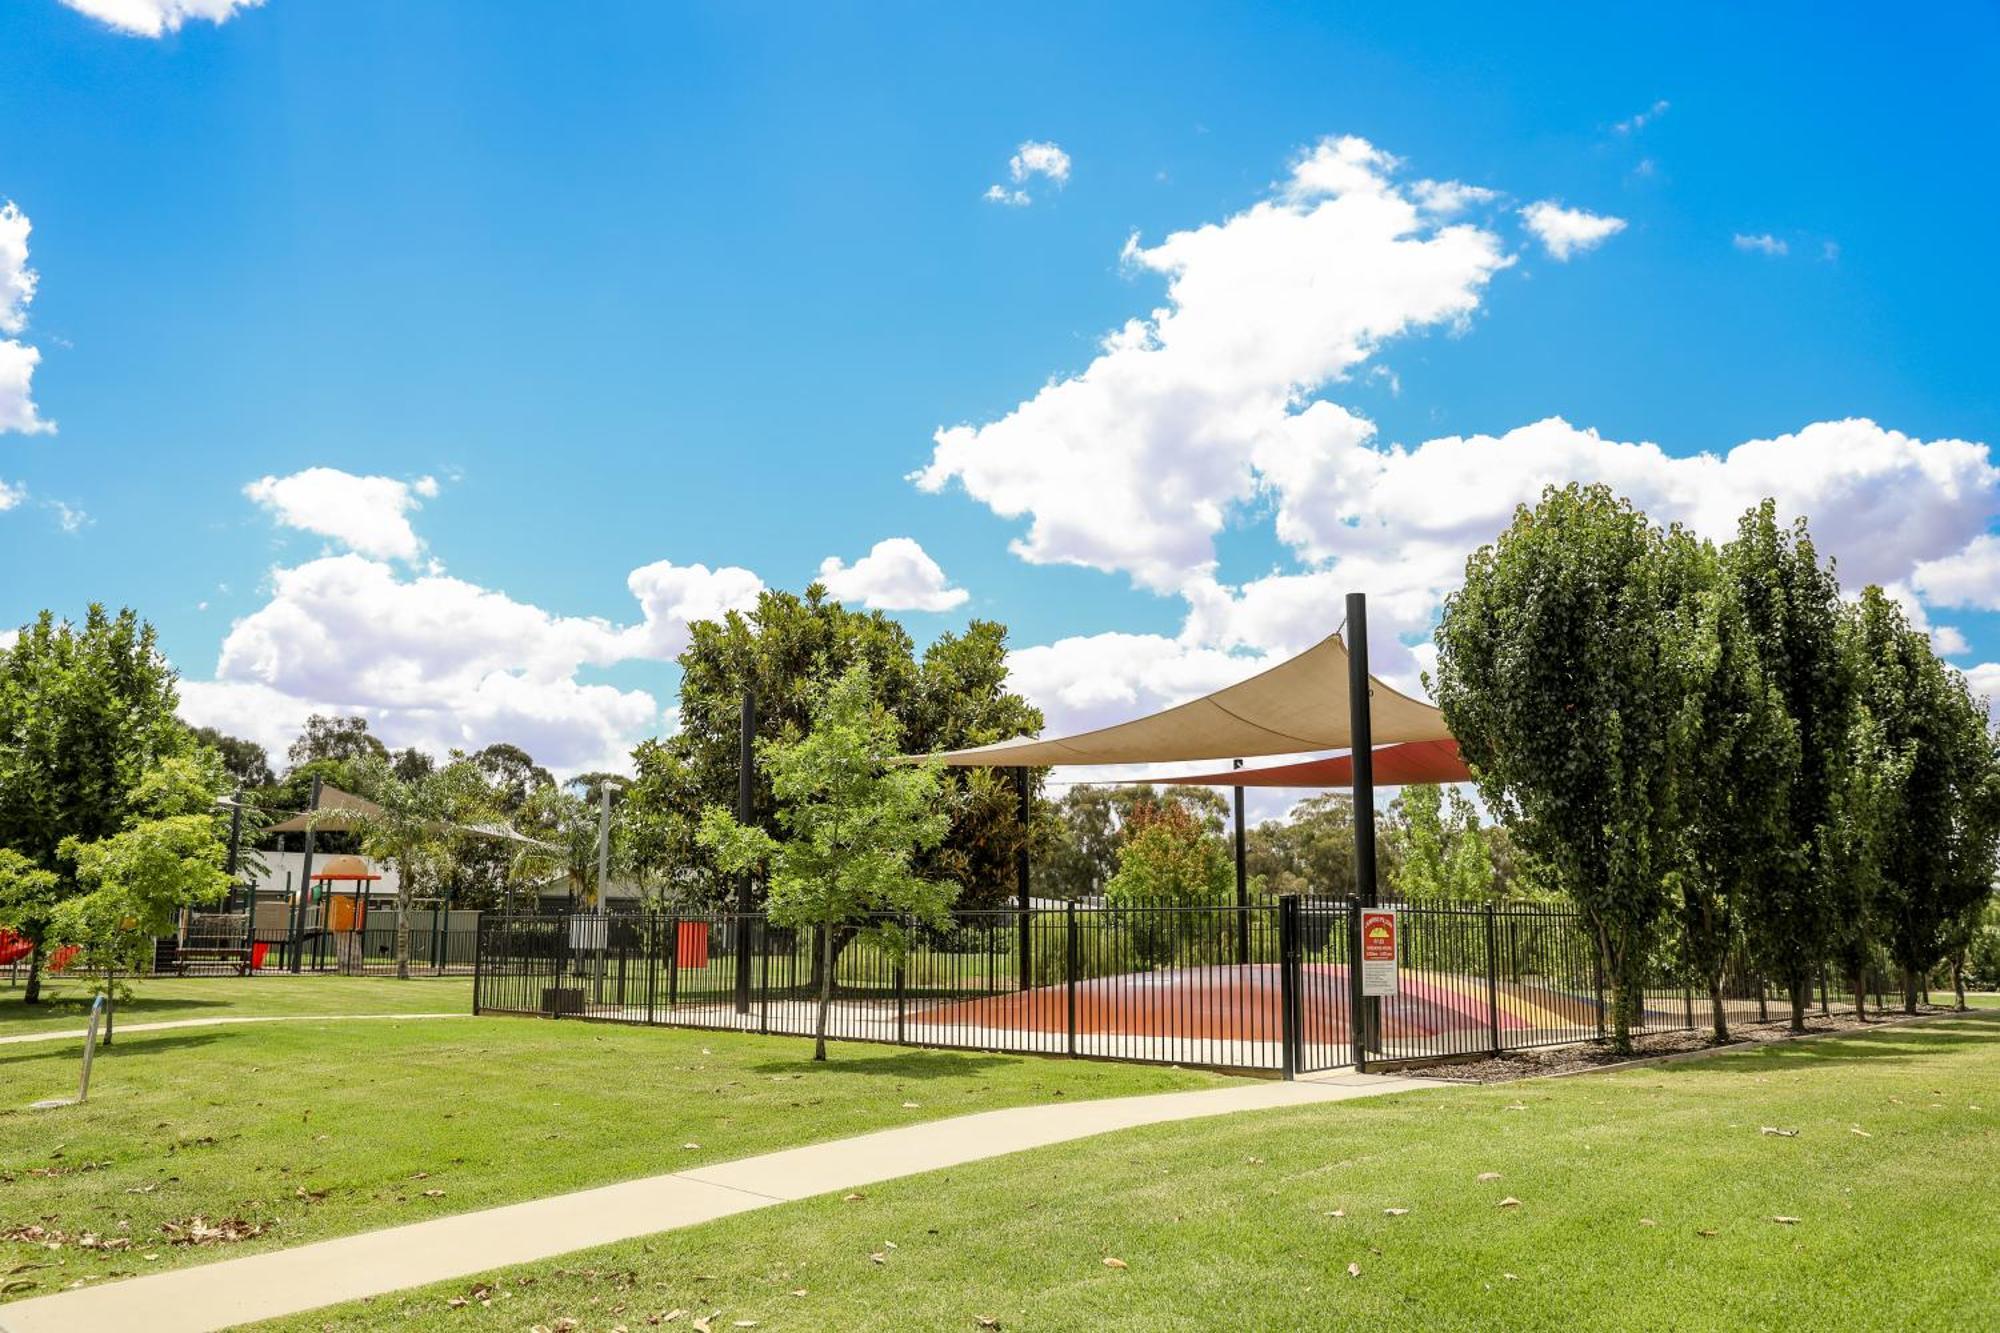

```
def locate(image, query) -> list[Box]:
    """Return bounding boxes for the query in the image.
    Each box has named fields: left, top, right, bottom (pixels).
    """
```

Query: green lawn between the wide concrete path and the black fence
left=0, top=1008, right=1226, bottom=1299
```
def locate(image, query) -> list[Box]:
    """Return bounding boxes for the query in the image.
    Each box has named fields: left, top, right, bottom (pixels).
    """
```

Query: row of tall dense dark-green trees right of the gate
left=1434, top=484, right=2000, bottom=1047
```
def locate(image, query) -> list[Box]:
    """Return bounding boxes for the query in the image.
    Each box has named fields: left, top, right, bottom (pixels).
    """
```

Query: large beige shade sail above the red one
left=916, top=634, right=1452, bottom=769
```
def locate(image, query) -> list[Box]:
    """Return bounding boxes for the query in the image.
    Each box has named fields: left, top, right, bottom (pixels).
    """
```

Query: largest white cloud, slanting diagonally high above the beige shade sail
left=928, top=138, right=1510, bottom=592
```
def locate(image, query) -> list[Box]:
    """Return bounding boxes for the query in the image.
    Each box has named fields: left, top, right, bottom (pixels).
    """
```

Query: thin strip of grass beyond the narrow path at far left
left=0, top=969, right=472, bottom=1037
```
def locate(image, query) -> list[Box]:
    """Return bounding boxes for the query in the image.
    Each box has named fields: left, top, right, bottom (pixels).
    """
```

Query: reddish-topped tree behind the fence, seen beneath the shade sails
left=1104, top=801, right=1236, bottom=967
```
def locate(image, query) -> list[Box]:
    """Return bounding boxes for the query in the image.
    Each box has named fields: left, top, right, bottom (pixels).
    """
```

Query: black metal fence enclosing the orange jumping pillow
left=472, top=899, right=1896, bottom=1077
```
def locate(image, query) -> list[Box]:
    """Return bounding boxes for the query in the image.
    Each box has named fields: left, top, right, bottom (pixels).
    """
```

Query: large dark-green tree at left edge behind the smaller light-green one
left=0, top=604, right=192, bottom=1005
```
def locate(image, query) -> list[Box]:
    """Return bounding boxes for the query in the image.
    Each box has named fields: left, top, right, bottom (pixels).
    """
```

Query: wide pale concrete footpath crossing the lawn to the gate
left=0, top=1073, right=1446, bottom=1333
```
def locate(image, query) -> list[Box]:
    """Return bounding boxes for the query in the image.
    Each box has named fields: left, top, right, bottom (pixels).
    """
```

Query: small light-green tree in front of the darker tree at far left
left=50, top=749, right=230, bottom=991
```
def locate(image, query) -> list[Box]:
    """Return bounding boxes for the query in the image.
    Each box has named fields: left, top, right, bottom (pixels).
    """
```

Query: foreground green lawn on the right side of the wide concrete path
left=270, top=1011, right=2000, bottom=1333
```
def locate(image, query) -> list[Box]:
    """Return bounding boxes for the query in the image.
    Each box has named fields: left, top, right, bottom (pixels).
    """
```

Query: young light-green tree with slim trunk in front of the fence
left=700, top=664, right=958, bottom=1061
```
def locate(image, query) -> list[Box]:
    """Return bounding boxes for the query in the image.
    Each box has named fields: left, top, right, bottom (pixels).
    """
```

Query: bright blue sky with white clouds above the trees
left=0, top=0, right=2000, bottom=767
